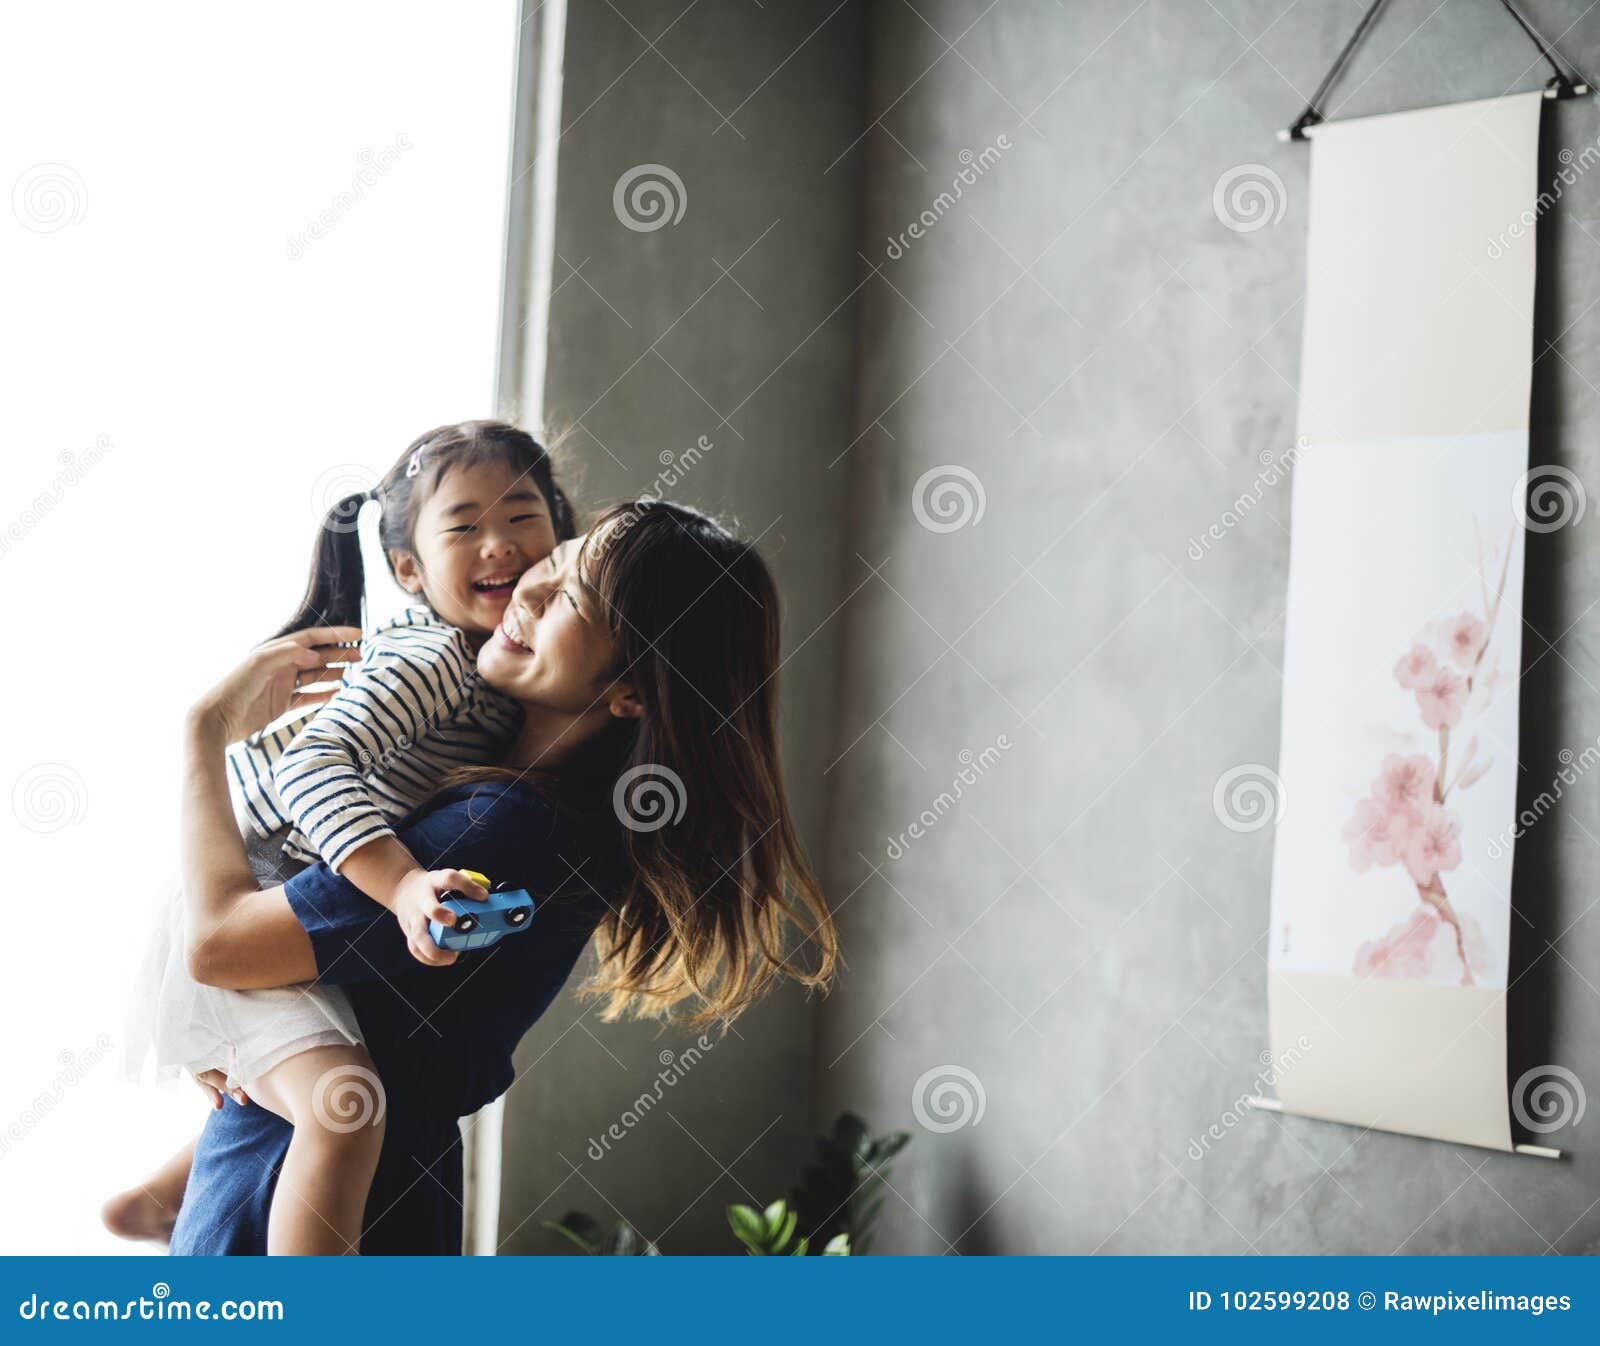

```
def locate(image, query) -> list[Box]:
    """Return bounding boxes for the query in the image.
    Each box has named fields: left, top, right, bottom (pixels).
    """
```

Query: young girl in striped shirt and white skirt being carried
left=104, top=421, right=573, bottom=1253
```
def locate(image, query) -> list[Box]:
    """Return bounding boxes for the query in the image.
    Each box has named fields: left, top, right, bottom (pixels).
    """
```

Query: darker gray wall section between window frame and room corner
left=501, top=0, right=866, bottom=1253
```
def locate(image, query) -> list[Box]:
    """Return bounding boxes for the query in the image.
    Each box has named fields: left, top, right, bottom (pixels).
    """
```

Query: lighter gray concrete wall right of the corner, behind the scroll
left=819, top=0, right=1600, bottom=1253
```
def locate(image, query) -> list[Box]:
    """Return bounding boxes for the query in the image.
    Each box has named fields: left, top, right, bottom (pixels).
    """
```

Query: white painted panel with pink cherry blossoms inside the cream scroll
left=1270, top=435, right=1523, bottom=986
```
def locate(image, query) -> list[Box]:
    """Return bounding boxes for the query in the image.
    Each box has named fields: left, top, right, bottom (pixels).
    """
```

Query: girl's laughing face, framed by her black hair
left=392, top=463, right=555, bottom=640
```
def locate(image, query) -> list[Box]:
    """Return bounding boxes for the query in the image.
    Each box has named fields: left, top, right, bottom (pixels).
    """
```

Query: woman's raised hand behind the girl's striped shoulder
left=189, top=626, right=362, bottom=743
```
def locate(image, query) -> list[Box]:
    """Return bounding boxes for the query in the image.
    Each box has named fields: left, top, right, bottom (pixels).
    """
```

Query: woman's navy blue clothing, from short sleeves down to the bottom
left=171, top=781, right=622, bottom=1256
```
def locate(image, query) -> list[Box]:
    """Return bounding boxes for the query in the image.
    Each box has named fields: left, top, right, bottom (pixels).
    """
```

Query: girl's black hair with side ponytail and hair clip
left=278, top=421, right=576, bottom=635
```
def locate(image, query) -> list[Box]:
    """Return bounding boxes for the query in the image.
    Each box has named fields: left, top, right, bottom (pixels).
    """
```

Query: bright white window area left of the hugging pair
left=0, top=0, right=517, bottom=1253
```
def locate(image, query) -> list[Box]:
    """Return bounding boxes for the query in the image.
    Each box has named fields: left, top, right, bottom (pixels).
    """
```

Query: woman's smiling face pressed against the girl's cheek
left=478, top=533, right=616, bottom=715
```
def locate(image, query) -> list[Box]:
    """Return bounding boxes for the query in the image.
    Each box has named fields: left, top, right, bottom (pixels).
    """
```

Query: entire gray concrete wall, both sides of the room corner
left=502, top=0, right=1600, bottom=1253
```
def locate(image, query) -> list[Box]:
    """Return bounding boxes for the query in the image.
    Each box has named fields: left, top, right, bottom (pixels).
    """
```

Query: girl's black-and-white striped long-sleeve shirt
left=227, top=608, right=522, bottom=871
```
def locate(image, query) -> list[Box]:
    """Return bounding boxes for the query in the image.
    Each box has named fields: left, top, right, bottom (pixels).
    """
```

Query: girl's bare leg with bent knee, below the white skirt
left=246, top=1047, right=384, bottom=1256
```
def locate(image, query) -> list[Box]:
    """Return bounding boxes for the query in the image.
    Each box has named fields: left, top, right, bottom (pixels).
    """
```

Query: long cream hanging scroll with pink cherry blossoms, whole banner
left=1267, top=93, right=1542, bottom=1149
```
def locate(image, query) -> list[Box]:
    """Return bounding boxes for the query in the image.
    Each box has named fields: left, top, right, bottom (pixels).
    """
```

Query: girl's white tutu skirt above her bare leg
left=126, top=834, right=362, bottom=1090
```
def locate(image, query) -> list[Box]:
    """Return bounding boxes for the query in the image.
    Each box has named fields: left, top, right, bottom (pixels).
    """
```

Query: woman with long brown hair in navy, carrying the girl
left=171, top=501, right=835, bottom=1253
